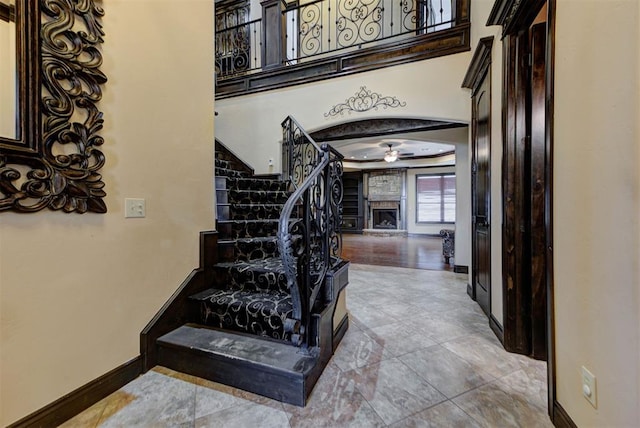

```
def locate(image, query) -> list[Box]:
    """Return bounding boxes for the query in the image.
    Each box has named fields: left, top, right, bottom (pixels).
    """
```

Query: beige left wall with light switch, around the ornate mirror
left=0, top=0, right=214, bottom=426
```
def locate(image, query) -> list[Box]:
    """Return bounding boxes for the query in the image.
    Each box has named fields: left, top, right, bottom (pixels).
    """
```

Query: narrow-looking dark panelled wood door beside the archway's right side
left=471, top=69, right=491, bottom=316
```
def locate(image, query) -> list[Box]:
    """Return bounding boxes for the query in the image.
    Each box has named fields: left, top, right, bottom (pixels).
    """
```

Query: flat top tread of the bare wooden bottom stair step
left=158, top=324, right=317, bottom=376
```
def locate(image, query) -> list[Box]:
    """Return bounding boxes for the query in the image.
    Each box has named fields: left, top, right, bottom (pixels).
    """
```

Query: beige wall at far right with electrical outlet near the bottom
left=553, top=0, right=640, bottom=427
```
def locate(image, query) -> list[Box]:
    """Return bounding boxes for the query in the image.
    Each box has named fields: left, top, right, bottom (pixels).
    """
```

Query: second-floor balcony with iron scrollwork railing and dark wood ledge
left=215, top=0, right=470, bottom=98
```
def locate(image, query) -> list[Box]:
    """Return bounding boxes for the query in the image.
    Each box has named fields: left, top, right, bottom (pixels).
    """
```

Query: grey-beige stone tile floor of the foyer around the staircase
left=63, top=264, right=553, bottom=428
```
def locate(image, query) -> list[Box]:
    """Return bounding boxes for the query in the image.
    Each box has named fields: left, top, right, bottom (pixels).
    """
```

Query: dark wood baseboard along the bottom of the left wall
left=7, top=356, right=142, bottom=428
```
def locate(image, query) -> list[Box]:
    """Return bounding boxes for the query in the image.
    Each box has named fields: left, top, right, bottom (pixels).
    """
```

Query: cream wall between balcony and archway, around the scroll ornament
left=216, top=52, right=471, bottom=173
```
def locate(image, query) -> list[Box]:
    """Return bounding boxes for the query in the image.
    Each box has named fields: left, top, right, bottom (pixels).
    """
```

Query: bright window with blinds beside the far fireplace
left=416, top=174, right=456, bottom=223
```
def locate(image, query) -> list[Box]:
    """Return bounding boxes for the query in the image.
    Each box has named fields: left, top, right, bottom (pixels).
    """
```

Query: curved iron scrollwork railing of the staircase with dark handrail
left=278, top=116, right=343, bottom=348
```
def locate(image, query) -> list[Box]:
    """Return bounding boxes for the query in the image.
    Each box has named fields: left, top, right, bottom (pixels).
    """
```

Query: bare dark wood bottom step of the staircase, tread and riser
left=157, top=324, right=323, bottom=406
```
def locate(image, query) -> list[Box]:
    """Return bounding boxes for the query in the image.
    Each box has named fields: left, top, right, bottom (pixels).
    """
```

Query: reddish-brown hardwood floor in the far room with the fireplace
left=342, top=233, right=453, bottom=272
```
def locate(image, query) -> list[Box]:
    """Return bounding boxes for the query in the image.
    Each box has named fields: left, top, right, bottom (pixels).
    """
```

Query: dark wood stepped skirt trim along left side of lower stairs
left=140, top=231, right=218, bottom=372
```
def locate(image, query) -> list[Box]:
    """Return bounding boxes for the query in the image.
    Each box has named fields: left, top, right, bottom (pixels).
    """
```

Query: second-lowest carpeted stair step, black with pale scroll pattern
left=214, top=257, right=289, bottom=293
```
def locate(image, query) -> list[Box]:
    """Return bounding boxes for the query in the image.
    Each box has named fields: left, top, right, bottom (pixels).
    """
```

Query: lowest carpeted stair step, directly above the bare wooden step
left=189, top=288, right=293, bottom=341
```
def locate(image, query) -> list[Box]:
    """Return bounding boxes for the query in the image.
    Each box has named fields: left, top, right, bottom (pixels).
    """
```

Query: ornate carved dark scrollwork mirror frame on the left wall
left=0, top=0, right=107, bottom=213
